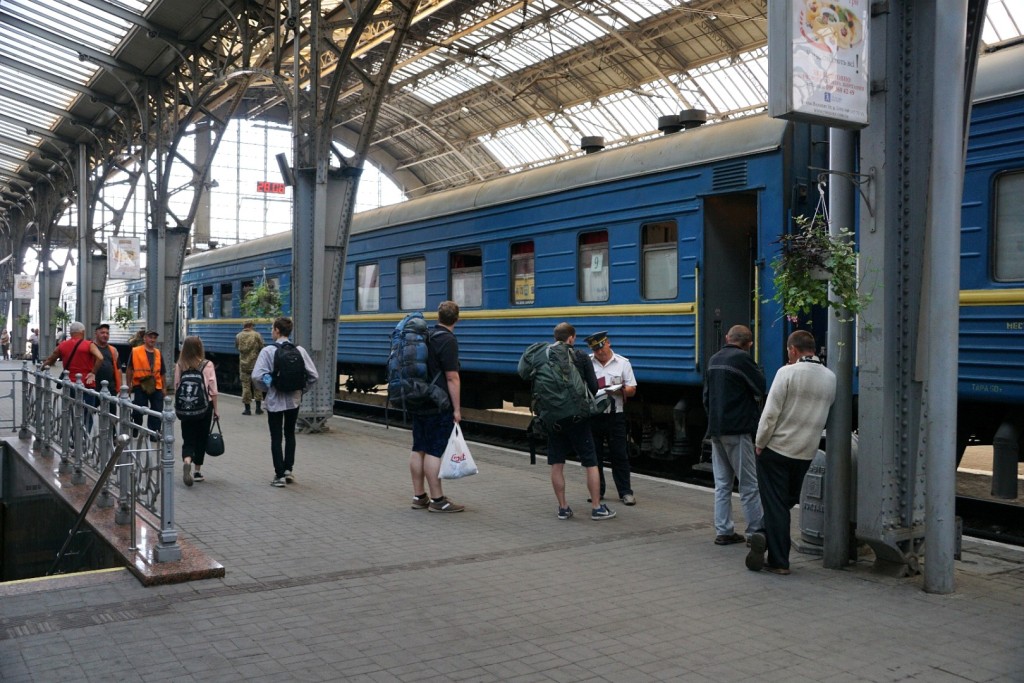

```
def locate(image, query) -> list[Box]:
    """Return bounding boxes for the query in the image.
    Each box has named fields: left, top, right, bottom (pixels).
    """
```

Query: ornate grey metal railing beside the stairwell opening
left=14, top=362, right=181, bottom=562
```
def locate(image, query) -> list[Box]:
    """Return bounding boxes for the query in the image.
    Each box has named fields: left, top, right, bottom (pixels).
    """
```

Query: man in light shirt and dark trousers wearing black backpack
left=252, top=317, right=319, bottom=488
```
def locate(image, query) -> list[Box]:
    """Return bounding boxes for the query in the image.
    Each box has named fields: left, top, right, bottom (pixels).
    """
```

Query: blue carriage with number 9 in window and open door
left=339, top=116, right=827, bottom=459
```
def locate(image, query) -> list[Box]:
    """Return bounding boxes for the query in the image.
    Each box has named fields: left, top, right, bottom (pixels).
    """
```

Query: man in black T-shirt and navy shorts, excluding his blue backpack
left=409, top=301, right=466, bottom=512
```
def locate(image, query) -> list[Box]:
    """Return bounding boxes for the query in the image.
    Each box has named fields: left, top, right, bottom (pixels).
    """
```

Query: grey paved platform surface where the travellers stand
left=0, top=389, right=1024, bottom=683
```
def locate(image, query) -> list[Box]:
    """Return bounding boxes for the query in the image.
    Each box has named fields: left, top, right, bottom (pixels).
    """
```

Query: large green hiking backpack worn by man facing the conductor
left=518, top=342, right=607, bottom=430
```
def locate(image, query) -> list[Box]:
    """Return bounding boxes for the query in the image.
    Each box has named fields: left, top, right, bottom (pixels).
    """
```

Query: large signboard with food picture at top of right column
left=768, top=0, right=871, bottom=129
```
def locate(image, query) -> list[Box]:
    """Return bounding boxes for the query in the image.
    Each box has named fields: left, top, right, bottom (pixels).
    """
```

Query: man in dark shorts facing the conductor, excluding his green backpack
left=548, top=323, right=615, bottom=520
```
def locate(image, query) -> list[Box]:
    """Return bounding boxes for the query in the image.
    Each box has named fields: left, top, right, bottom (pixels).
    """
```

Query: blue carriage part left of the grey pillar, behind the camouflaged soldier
left=177, top=232, right=292, bottom=391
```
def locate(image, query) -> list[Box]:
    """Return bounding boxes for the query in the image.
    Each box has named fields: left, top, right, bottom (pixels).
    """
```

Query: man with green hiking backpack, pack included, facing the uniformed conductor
left=519, top=323, right=615, bottom=521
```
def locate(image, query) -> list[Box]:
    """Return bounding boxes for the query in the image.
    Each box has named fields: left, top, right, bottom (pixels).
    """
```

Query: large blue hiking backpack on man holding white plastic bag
left=387, top=312, right=452, bottom=414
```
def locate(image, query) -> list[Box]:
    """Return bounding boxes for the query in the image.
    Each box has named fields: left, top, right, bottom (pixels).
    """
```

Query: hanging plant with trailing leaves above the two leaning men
left=765, top=215, right=871, bottom=323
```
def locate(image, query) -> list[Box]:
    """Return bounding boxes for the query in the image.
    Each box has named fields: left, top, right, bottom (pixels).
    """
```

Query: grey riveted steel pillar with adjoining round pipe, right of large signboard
left=857, top=0, right=967, bottom=591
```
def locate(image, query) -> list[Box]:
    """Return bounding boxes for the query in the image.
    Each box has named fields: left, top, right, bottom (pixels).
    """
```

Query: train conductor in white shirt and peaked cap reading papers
left=587, top=332, right=637, bottom=505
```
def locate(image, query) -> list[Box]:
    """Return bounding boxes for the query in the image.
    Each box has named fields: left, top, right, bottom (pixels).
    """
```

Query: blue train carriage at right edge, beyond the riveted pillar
left=957, top=45, right=1024, bottom=458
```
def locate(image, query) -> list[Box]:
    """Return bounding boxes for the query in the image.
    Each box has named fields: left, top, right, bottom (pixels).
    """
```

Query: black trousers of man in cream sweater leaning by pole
left=757, top=449, right=811, bottom=569
